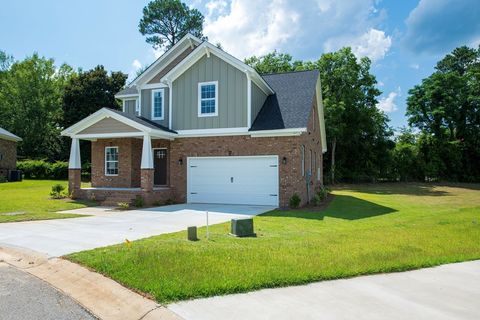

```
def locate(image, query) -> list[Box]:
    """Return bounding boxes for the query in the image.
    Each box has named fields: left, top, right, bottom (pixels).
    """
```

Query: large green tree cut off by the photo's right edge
left=406, top=46, right=480, bottom=181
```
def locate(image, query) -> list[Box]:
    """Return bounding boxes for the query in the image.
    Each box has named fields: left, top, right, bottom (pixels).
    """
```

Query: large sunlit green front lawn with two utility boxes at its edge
left=68, top=184, right=480, bottom=303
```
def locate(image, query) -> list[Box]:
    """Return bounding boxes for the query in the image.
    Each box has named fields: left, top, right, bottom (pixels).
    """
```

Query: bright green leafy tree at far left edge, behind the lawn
left=0, top=53, right=71, bottom=160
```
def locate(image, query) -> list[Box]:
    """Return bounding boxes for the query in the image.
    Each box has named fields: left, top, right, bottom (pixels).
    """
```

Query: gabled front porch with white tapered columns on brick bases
left=65, top=109, right=178, bottom=205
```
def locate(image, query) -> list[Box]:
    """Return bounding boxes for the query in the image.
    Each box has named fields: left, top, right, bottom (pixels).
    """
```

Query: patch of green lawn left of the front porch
left=0, top=180, right=93, bottom=223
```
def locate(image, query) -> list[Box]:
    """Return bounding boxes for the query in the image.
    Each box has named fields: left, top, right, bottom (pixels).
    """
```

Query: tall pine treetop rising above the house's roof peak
left=138, top=0, right=204, bottom=49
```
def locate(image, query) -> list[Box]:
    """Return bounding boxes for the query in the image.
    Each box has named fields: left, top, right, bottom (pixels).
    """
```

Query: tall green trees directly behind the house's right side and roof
left=245, top=48, right=394, bottom=182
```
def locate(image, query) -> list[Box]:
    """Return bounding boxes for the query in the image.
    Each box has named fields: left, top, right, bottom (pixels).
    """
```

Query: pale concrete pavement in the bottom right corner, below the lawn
left=168, top=261, right=480, bottom=320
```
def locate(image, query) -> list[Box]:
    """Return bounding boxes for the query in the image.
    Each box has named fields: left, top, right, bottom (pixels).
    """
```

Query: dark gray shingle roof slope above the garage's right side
left=250, top=70, right=319, bottom=131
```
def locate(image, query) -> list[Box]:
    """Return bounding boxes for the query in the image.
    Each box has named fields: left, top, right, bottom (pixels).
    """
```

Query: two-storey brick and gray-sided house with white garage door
left=62, top=35, right=326, bottom=207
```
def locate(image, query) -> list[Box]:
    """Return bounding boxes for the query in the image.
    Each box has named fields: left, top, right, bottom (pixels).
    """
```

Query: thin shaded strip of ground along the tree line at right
left=335, top=183, right=449, bottom=196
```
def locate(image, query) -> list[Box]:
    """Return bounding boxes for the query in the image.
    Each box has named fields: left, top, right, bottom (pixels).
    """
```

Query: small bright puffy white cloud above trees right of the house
left=352, top=28, right=392, bottom=62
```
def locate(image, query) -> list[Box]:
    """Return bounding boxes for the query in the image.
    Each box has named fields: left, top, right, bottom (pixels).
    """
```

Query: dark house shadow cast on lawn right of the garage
left=261, top=195, right=397, bottom=220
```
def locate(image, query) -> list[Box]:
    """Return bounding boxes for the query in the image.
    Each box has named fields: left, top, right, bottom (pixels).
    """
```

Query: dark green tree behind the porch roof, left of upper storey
left=62, top=66, right=127, bottom=128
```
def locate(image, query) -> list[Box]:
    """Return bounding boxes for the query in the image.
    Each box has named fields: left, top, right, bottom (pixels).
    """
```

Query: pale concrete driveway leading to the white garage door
left=0, top=204, right=274, bottom=257
